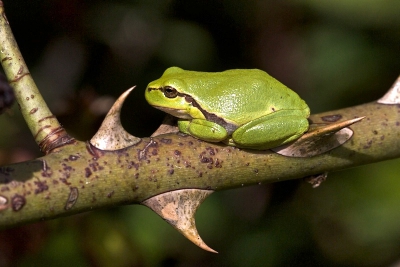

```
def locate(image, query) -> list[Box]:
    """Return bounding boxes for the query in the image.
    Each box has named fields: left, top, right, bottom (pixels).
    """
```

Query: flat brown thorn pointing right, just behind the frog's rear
left=271, top=117, right=365, bottom=158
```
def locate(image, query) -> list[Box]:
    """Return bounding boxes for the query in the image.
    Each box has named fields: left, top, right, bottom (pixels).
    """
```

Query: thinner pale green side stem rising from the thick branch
left=0, top=1, right=73, bottom=153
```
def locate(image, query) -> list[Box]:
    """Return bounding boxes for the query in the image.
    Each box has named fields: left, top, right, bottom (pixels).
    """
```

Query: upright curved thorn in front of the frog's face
left=90, top=86, right=140, bottom=150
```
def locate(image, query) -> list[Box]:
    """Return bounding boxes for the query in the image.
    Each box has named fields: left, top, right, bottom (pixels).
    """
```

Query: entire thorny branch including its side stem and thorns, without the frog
left=0, top=1, right=400, bottom=251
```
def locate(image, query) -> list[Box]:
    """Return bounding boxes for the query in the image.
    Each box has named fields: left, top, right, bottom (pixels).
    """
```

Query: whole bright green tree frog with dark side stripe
left=145, top=67, right=310, bottom=150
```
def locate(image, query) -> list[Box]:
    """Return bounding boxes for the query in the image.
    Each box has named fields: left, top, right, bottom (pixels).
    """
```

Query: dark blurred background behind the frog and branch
left=0, top=0, right=400, bottom=267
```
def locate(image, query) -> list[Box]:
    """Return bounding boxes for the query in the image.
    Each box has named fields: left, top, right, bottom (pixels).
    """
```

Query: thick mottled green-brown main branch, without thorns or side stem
left=0, top=97, right=400, bottom=228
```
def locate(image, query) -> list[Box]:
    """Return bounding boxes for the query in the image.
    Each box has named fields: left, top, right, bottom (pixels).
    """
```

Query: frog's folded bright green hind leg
left=232, top=110, right=308, bottom=149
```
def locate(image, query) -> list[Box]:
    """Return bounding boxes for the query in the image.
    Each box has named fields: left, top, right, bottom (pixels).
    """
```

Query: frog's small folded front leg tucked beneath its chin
left=178, top=119, right=228, bottom=142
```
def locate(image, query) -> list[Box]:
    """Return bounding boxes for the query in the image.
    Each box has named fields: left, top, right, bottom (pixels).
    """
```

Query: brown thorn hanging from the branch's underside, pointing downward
left=142, top=189, right=218, bottom=253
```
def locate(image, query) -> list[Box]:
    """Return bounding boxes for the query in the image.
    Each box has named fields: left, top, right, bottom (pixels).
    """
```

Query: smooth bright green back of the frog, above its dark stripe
left=178, top=69, right=309, bottom=124
